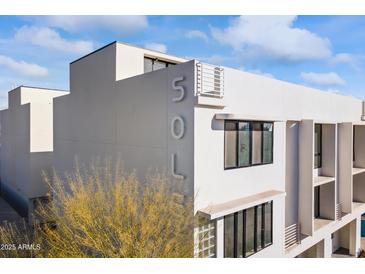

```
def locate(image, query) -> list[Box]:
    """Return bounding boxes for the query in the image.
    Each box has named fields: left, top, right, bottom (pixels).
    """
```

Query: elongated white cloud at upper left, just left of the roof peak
left=14, top=26, right=94, bottom=54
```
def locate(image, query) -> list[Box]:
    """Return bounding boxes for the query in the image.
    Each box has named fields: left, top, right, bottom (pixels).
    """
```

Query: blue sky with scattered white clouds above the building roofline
left=0, top=16, right=365, bottom=108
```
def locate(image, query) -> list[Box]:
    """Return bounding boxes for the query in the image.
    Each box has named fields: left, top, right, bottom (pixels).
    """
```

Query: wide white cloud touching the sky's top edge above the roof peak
left=31, top=15, right=148, bottom=34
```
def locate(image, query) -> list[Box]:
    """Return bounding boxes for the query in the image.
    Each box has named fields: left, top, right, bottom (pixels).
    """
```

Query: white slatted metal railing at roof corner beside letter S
left=196, top=63, right=224, bottom=98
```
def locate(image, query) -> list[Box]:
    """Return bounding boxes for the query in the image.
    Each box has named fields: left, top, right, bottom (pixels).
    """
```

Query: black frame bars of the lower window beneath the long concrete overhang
left=223, top=200, right=274, bottom=258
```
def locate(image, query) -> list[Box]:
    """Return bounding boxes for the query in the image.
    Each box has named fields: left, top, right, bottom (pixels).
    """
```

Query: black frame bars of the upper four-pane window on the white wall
left=223, top=119, right=275, bottom=170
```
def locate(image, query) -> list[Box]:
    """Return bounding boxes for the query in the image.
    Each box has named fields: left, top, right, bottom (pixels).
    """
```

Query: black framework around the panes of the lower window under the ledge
left=224, top=201, right=274, bottom=258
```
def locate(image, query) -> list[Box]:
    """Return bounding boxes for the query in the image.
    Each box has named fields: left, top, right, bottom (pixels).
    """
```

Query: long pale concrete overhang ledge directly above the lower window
left=198, top=190, right=286, bottom=220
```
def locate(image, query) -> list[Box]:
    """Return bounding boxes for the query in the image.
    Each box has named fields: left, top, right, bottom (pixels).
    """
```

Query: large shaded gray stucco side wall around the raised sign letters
left=53, top=42, right=194, bottom=192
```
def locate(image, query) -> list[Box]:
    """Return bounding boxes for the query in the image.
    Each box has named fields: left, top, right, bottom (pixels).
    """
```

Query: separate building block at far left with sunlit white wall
left=0, top=87, right=67, bottom=215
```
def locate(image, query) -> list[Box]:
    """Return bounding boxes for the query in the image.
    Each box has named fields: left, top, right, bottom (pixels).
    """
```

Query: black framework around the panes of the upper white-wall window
left=223, top=120, right=274, bottom=170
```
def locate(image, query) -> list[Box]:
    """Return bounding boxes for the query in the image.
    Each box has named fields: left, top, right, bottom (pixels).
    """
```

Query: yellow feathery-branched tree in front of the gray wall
left=0, top=161, right=194, bottom=258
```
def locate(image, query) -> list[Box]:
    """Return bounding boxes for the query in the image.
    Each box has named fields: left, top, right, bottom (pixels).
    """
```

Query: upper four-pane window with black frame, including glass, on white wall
left=224, top=120, right=274, bottom=169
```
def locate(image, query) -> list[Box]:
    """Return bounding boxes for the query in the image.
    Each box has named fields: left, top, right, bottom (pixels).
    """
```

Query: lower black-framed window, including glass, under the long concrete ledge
left=224, top=201, right=273, bottom=258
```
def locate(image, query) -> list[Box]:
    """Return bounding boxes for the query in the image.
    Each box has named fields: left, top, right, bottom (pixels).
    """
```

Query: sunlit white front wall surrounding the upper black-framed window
left=194, top=68, right=362, bottom=257
